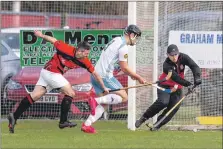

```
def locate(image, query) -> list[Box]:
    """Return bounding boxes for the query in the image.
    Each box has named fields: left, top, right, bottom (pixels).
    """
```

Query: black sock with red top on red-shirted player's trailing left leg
left=13, top=94, right=35, bottom=120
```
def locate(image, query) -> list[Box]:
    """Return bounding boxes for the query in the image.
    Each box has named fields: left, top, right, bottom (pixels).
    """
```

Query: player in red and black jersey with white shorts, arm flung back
left=8, top=31, right=109, bottom=133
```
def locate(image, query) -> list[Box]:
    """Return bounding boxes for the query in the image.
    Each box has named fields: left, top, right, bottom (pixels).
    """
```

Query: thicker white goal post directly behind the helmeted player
left=128, top=2, right=136, bottom=130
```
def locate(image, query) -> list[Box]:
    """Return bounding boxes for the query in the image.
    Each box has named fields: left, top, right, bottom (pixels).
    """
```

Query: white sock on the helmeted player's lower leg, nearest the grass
left=84, top=105, right=105, bottom=126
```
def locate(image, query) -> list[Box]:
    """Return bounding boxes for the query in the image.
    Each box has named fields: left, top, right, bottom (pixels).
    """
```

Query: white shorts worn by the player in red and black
left=36, top=69, right=69, bottom=92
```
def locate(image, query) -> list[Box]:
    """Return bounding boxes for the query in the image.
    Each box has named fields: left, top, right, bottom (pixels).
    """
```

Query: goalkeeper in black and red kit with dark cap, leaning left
left=135, top=44, right=201, bottom=131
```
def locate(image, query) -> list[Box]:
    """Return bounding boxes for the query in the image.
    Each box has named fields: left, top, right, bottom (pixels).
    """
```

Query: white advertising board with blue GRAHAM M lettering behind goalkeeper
left=169, top=31, right=223, bottom=68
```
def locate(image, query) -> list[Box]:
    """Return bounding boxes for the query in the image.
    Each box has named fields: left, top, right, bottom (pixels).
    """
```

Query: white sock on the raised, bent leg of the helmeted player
left=95, top=94, right=122, bottom=104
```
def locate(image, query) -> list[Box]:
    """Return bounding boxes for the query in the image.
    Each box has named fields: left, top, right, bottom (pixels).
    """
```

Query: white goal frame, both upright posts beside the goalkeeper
left=128, top=2, right=159, bottom=131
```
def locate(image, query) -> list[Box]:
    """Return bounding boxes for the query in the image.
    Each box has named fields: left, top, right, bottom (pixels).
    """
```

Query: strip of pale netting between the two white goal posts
left=136, top=2, right=154, bottom=125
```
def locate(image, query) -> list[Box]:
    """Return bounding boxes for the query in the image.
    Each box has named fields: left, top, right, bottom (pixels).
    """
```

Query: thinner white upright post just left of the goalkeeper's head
left=153, top=2, right=159, bottom=124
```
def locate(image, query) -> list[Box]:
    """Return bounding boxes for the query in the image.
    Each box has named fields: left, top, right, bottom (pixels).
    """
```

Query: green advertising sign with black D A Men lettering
left=20, top=30, right=123, bottom=66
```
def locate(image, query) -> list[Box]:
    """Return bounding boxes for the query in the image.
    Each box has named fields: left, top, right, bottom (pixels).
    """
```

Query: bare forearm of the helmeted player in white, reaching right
left=119, top=61, right=146, bottom=84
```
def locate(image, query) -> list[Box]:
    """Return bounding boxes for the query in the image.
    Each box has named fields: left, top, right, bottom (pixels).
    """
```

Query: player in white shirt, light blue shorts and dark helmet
left=81, top=25, right=146, bottom=133
